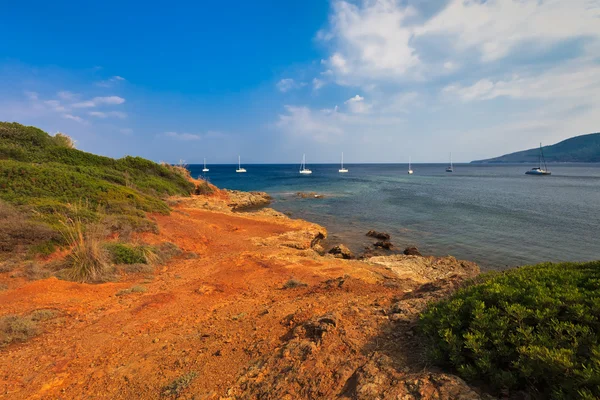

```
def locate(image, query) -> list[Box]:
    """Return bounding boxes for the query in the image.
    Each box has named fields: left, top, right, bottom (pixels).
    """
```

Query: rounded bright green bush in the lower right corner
left=419, top=262, right=600, bottom=399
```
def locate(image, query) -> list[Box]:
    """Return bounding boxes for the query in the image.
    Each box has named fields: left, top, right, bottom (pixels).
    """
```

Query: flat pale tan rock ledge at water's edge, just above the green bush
left=366, top=254, right=479, bottom=283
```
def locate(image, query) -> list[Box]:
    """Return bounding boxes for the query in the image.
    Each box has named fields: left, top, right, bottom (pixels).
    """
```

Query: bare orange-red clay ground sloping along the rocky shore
left=0, top=192, right=478, bottom=399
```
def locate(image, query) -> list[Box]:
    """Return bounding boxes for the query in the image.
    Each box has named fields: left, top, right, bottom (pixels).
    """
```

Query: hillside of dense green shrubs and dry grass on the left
left=0, top=122, right=195, bottom=280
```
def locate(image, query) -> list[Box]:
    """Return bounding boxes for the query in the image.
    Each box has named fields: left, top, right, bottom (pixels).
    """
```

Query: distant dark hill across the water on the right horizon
left=472, top=133, right=600, bottom=164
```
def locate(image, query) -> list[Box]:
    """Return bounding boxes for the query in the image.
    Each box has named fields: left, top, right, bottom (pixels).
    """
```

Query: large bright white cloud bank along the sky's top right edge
left=317, top=0, right=600, bottom=86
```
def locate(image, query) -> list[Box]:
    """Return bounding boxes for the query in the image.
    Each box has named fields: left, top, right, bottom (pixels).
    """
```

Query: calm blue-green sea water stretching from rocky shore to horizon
left=189, top=164, right=600, bottom=269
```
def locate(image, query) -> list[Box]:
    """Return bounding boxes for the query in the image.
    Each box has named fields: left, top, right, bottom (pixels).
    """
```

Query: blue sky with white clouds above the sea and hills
left=0, top=0, right=600, bottom=165
